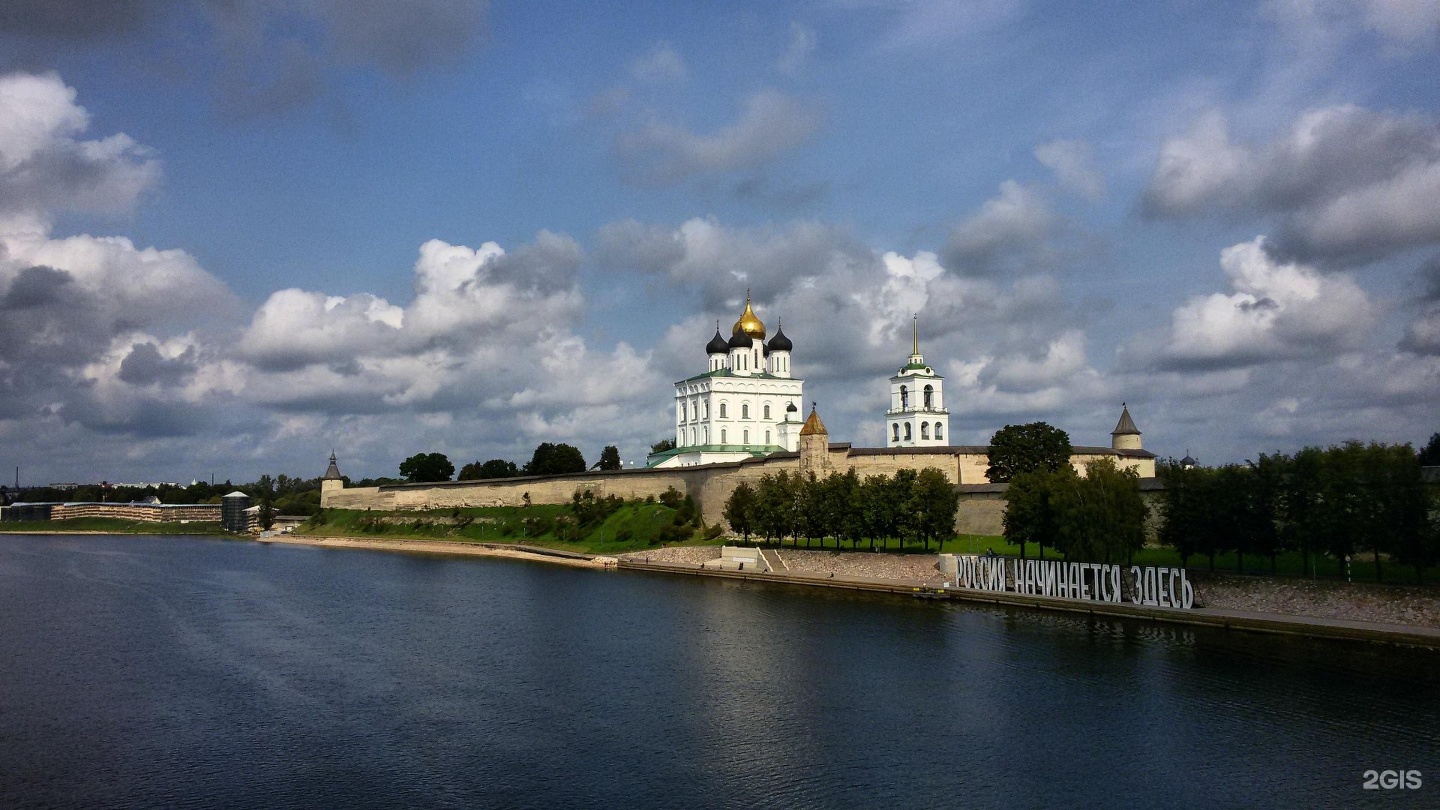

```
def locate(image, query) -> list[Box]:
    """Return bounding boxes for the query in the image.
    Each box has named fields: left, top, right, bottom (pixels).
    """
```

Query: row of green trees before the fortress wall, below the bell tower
left=724, top=467, right=959, bottom=549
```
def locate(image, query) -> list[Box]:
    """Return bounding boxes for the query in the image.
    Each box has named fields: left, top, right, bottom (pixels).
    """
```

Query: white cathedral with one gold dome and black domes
left=648, top=294, right=805, bottom=467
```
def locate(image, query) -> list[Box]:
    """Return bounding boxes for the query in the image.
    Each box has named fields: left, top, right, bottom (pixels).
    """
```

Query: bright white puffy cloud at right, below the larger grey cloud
left=1140, top=236, right=1375, bottom=369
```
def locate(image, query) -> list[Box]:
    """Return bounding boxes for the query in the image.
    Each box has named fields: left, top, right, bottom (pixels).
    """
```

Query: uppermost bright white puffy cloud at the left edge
left=0, top=74, right=160, bottom=215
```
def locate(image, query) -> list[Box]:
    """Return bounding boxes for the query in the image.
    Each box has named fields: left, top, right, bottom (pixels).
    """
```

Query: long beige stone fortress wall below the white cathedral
left=321, top=427, right=1155, bottom=535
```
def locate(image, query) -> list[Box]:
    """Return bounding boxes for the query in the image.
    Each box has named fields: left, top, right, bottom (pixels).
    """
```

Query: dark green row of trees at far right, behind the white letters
left=1156, top=440, right=1440, bottom=581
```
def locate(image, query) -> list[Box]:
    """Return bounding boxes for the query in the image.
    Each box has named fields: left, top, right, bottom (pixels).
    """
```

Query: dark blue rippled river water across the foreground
left=0, top=536, right=1440, bottom=807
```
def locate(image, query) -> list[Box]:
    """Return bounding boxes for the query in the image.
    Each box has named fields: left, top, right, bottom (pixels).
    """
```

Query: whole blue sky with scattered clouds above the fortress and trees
left=0, top=0, right=1440, bottom=484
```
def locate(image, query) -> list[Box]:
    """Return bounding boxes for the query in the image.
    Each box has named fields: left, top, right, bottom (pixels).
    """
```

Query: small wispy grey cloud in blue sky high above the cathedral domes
left=613, top=89, right=822, bottom=184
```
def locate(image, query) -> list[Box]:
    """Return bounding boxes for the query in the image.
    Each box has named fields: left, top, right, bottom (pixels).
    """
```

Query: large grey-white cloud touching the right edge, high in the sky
left=1143, top=105, right=1440, bottom=261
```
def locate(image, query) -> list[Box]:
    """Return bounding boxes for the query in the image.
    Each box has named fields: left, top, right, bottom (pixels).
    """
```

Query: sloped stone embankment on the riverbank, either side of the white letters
left=621, top=546, right=1440, bottom=628
